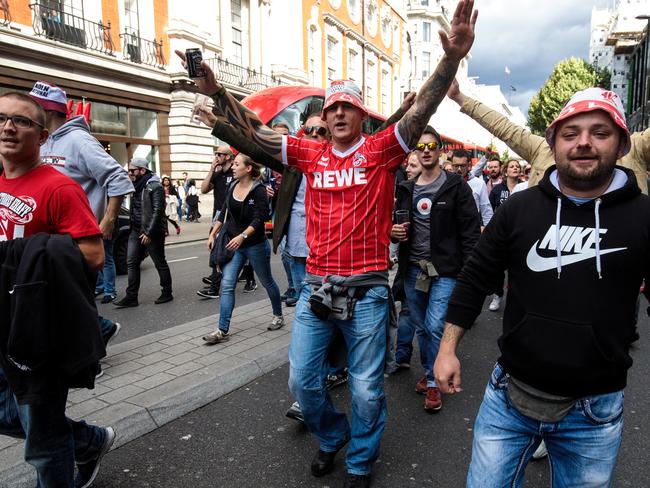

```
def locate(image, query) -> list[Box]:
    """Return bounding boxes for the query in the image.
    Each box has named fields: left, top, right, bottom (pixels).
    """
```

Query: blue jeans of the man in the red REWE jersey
left=289, top=284, right=389, bottom=475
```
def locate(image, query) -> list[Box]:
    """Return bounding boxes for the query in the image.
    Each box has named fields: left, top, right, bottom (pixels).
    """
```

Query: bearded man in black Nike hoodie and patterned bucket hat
left=434, top=88, right=650, bottom=488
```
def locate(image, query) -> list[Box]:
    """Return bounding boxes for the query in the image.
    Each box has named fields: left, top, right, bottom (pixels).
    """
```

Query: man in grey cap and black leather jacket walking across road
left=114, top=158, right=174, bottom=308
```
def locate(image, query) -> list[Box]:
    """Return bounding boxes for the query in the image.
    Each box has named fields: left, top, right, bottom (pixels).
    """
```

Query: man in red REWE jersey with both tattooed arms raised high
left=176, top=0, right=477, bottom=488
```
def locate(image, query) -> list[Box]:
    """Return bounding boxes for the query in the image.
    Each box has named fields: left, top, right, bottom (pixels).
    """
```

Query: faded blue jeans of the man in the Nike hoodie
left=467, top=363, right=624, bottom=488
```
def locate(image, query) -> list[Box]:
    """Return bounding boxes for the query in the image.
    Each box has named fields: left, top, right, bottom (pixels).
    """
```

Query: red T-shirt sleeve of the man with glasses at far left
left=48, top=183, right=101, bottom=239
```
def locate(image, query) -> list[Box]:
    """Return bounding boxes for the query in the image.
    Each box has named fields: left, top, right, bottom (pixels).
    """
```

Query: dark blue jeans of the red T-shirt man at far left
left=0, top=368, right=106, bottom=488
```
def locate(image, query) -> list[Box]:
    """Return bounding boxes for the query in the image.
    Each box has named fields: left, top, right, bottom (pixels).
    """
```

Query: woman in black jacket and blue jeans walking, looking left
left=203, top=153, right=284, bottom=344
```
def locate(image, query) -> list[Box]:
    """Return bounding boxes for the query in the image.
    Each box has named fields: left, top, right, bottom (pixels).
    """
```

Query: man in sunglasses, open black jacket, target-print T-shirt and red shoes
left=392, top=126, right=481, bottom=412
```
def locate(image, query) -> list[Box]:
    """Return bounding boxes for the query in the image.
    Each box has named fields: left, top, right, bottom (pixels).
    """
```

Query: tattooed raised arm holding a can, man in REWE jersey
left=176, top=50, right=282, bottom=161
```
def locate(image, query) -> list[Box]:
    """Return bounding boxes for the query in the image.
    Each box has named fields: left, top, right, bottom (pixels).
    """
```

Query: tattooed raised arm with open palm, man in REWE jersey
left=397, top=0, right=478, bottom=147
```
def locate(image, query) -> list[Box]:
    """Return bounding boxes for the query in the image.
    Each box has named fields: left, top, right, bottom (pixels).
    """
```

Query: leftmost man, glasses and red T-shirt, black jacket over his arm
left=0, top=92, right=115, bottom=488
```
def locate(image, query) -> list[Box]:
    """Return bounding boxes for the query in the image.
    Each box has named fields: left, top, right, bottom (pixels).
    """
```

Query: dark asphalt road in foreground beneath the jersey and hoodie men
left=94, top=304, right=650, bottom=488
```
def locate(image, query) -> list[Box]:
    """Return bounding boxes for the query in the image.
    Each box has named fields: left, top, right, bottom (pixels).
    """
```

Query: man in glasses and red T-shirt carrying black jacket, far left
left=0, top=92, right=115, bottom=488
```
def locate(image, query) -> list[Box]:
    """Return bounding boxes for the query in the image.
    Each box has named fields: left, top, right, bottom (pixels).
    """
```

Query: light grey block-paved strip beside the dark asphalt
left=0, top=296, right=295, bottom=487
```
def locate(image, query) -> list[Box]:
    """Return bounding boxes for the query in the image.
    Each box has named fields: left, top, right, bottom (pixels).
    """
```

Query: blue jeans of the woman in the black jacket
left=219, top=239, right=282, bottom=332
